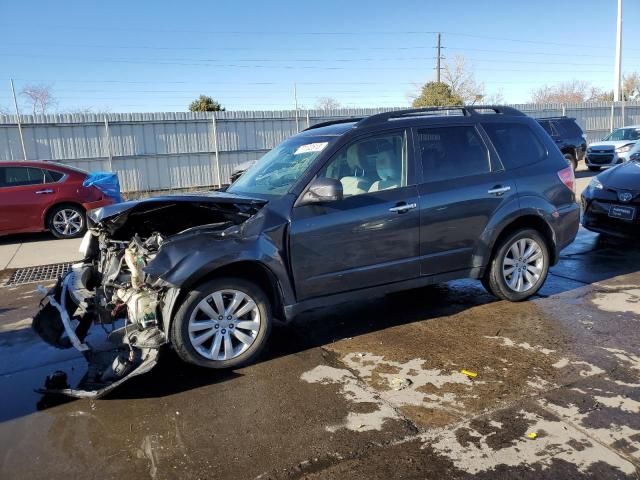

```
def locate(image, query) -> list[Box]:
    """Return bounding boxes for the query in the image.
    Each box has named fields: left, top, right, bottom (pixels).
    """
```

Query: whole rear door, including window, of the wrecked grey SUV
left=414, top=123, right=517, bottom=275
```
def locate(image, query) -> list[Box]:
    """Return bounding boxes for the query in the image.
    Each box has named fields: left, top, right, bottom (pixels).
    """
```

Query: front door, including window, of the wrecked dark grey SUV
left=290, top=130, right=420, bottom=301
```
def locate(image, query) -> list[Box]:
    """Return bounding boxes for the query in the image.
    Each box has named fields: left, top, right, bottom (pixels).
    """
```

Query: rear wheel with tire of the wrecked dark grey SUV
left=483, top=228, right=550, bottom=302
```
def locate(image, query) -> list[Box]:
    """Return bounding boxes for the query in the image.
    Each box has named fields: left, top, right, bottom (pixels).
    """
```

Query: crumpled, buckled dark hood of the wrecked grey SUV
left=88, top=192, right=267, bottom=240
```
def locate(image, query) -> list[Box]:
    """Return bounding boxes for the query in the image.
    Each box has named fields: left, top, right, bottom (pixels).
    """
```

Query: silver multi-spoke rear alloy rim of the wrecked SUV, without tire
left=502, top=238, right=544, bottom=292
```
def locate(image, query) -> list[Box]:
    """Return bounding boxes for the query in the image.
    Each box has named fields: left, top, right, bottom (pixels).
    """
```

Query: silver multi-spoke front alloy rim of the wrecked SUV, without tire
left=188, top=289, right=261, bottom=360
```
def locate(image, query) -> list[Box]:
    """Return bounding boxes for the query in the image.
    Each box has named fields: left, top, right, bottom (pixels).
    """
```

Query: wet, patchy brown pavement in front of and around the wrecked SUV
left=0, top=226, right=640, bottom=479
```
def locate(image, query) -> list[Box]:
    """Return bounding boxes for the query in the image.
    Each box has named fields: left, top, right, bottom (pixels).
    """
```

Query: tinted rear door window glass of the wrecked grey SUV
left=416, top=125, right=491, bottom=183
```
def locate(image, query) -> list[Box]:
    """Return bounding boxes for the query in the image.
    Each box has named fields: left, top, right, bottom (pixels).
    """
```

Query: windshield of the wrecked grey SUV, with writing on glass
left=227, top=136, right=336, bottom=196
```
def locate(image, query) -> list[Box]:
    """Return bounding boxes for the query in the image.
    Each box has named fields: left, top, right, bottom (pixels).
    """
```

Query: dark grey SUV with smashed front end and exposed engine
left=36, top=107, right=579, bottom=393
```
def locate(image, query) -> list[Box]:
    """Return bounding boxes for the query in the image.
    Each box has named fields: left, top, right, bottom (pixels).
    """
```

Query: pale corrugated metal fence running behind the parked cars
left=0, top=102, right=640, bottom=192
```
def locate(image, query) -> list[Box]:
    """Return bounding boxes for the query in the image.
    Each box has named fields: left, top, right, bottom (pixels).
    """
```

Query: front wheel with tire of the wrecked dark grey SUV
left=171, top=277, right=273, bottom=369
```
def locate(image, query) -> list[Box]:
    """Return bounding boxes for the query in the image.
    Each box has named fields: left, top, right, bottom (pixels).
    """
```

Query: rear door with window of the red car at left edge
left=0, top=166, right=58, bottom=232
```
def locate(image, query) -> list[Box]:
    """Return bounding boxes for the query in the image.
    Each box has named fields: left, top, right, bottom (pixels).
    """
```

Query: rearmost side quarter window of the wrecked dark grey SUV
left=482, top=122, right=547, bottom=170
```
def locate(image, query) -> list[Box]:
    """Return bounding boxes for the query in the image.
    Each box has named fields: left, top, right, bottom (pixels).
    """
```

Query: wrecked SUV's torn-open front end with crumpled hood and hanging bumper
left=33, top=193, right=266, bottom=398
